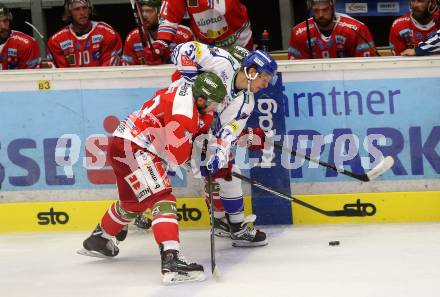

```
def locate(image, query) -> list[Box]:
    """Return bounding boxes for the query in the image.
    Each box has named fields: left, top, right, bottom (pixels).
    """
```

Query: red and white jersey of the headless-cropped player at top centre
left=157, top=0, right=252, bottom=48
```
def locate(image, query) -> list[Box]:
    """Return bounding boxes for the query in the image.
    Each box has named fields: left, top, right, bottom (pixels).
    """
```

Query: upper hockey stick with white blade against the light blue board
left=273, top=143, right=394, bottom=182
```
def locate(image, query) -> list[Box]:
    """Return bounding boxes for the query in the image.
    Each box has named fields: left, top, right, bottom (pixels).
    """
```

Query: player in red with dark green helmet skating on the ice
left=79, top=72, right=226, bottom=283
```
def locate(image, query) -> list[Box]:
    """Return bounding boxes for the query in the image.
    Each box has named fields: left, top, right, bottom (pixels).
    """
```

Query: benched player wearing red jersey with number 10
left=47, top=0, right=122, bottom=68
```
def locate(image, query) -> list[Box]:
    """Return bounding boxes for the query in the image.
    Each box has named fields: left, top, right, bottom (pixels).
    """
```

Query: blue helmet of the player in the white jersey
left=243, top=50, right=278, bottom=85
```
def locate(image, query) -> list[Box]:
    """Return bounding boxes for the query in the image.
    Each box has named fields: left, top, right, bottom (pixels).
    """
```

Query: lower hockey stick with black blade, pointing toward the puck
left=231, top=172, right=366, bottom=217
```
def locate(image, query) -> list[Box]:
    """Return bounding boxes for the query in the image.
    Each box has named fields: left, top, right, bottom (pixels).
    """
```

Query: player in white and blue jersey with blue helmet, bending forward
left=172, top=41, right=278, bottom=246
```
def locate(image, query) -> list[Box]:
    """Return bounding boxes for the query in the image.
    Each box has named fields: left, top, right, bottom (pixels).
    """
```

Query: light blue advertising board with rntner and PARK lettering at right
left=284, top=78, right=440, bottom=182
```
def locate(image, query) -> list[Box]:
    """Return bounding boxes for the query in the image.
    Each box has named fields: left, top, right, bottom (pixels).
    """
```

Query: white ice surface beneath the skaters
left=0, top=223, right=440, bottom=297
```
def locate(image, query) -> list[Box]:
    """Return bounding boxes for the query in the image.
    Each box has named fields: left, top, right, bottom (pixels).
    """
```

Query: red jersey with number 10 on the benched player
left=47, top=22, right=122, bottom=68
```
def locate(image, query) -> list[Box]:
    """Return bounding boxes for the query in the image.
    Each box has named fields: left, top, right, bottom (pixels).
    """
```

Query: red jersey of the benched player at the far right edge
left=390, top=13, right=440, bottom=56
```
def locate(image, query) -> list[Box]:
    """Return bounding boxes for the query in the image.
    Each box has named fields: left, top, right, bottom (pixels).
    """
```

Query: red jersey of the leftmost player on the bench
left=0, top=30, right=41, bottom=70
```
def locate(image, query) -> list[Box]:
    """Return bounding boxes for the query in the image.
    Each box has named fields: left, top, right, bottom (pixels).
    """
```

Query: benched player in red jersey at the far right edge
left=390, top=0, right=440, bottom=56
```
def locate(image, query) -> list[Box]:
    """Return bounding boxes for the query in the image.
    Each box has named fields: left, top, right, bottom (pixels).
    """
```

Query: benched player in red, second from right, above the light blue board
left=288, top=0, right=377, bottom=59
